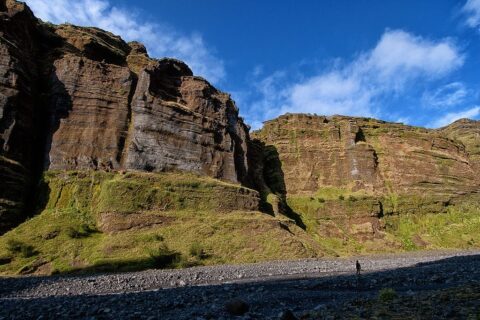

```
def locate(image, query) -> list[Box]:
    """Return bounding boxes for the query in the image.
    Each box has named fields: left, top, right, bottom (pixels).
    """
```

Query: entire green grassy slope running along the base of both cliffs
left=0, top=171, right=480, bottom=275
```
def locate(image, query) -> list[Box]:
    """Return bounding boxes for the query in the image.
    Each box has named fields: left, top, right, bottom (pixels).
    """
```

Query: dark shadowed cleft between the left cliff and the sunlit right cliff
left=249, top=139, right=306, bottom=230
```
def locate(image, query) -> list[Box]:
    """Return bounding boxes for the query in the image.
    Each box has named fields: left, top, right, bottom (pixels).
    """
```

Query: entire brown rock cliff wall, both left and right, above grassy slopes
left=0, top=0, right=480, bottom=245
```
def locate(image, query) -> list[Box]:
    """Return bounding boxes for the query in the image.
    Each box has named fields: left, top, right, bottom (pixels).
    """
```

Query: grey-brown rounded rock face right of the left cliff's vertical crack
left=125, top=59, right=248, bottom=182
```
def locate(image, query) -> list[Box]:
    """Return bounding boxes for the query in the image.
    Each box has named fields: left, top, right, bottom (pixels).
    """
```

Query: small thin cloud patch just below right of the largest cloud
left=422, top=82, right=468, bottom=108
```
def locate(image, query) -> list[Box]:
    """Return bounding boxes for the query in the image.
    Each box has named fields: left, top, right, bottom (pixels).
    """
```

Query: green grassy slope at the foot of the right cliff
left=287, top=193, right=480, bottom=256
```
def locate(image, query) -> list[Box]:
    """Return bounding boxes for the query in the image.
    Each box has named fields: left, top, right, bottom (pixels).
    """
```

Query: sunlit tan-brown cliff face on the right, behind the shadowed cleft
left=252, top=114, right=480, bottom=237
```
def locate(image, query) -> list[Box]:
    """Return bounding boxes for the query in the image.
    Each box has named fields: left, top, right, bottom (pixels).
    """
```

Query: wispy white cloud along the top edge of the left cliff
left=26, top=0, right=225, bottom=82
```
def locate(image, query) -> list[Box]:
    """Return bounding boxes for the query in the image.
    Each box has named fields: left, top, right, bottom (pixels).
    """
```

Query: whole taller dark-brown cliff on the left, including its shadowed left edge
left=0, top=0, right=253, bottom=233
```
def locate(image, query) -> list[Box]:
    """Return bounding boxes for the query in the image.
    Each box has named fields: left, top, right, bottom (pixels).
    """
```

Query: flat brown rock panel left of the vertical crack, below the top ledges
left=45, top=54, right=133, bottom=170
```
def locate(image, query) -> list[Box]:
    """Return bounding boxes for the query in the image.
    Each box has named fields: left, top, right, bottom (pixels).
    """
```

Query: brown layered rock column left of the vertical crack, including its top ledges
left=45, top=26, right=135, bottom=170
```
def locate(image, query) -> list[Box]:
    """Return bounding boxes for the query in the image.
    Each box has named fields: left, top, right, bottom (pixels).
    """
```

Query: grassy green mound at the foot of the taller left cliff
left=0, top=171, right=316, bottom=274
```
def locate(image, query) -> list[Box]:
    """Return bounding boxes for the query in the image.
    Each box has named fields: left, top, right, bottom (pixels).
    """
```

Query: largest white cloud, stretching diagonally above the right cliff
left=249, top=30, right=464, bottom=126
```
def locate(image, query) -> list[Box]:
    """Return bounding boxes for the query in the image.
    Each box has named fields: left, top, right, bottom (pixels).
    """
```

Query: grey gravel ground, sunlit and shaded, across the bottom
left=0, top=250, right=480, bottom=320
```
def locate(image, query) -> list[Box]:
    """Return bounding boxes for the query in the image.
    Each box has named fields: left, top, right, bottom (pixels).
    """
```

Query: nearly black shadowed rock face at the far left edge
left=0, top=0, right=40, bottom=233
